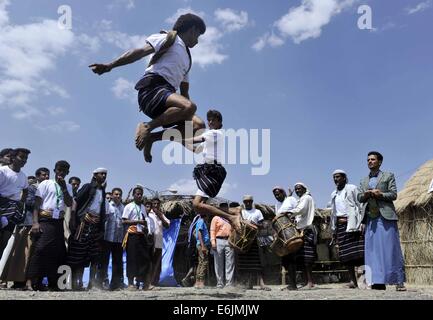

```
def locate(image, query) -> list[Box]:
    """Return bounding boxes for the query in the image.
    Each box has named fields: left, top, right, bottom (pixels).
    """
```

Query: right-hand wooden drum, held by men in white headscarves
left=272, top=214, right=304, bottom=255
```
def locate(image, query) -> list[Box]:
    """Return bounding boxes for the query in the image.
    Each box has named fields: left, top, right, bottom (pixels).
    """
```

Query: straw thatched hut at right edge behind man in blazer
left=395, top=159, right=433, bottom=284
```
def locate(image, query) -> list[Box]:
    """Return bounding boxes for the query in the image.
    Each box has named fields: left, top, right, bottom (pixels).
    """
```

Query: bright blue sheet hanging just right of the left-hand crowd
left=158, top=219, right=182, bottom=287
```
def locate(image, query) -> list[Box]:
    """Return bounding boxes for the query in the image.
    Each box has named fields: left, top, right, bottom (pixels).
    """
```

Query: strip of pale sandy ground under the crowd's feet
left=0, top=284, right=433, bottom=300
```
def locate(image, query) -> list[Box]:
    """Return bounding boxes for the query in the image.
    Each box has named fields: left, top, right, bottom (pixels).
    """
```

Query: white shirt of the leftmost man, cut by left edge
left=0, top=166, right=29, bottom=201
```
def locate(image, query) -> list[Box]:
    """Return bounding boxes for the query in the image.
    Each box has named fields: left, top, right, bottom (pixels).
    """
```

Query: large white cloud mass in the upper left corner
left=0, top=0, right=75, bottom=119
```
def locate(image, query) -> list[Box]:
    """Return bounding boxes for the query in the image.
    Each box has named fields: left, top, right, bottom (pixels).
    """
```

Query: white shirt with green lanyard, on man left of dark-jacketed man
left=35, top=180, right=72, bottom=211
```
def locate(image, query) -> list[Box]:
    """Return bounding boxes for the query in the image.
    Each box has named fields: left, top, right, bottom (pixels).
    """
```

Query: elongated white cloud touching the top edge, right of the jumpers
left=252, top=0, right=358, bottom=51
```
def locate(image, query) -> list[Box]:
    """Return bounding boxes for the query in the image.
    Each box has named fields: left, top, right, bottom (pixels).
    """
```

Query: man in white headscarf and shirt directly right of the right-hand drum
left=286, top=182, right=317, bottom=290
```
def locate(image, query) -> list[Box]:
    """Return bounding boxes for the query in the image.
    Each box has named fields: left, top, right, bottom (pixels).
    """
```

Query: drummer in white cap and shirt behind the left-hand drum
left=237, top=195, right=271, bottom=291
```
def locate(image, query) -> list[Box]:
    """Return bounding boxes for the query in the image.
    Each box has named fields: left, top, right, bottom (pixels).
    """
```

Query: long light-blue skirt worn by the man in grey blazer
left=365, top=216, right=406, bottom=285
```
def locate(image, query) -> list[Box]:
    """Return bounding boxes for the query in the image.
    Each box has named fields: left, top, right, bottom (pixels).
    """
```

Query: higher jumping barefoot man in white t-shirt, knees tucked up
left=89, top=13, right=206, bottom=162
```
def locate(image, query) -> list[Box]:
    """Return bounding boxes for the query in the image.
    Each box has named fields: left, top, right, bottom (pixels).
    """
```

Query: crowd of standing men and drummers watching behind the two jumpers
left=0, top=148, right=406, bottom=291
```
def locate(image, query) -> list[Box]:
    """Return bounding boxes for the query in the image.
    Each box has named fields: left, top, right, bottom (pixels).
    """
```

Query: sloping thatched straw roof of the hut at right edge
left=394, top=159, right=433, bottom=213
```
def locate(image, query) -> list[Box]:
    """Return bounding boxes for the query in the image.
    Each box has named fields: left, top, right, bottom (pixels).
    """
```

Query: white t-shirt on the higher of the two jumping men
left=146, top=33, right=191, bottom=90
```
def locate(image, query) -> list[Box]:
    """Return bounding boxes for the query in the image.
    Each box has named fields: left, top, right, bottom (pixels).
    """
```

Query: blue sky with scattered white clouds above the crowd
left=0, top=0, right=433, bottom=207
